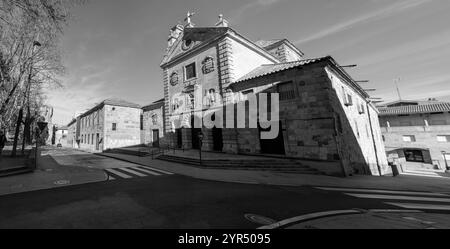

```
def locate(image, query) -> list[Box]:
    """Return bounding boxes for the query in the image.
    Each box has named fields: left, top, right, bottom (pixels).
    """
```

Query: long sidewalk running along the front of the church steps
left=98, top=153, right=450, bottom=193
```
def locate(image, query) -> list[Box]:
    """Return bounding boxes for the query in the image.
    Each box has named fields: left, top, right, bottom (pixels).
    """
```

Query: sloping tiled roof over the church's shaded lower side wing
left=235, top=56, right=330, bottom=83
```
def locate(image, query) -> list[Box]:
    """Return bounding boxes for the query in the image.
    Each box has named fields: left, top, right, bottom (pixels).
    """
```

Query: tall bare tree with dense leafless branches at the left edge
left=0, top=0, right=85, bottom=156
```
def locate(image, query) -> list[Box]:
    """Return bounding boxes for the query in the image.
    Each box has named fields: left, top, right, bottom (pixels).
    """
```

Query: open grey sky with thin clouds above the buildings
left=47, top=0, right=450, bottom=125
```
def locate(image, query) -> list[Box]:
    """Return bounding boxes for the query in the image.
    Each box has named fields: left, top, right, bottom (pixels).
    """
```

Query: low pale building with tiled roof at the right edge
left=379, top=100, right=450, bottom=170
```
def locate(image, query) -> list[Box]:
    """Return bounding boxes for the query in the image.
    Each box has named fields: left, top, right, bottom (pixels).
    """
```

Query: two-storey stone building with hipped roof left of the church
left=75, top=99, right=141, bottom=152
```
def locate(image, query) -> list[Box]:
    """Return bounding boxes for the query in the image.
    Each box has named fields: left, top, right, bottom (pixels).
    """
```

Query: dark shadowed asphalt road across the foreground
left=0, top=172, right=404, bottom=229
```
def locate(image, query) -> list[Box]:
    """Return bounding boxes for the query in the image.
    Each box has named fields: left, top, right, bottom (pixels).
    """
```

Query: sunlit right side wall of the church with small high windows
left=326, top=68, right=389, bottom=175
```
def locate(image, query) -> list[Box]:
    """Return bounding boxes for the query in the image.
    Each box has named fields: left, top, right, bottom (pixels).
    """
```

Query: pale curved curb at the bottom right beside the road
left=258, top=209, right=423, bottom=230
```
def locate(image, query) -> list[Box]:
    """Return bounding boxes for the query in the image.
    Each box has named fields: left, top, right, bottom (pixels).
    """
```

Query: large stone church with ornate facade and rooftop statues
left=161, top=14, right=389, bottom=175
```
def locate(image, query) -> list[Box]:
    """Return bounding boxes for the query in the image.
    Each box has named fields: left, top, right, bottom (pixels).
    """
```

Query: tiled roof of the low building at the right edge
left=379, top=102, right=450, bottom=116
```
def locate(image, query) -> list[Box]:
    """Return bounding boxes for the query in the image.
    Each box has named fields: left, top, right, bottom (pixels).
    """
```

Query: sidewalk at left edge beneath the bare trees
left=0, top=152, right=106, bottom=196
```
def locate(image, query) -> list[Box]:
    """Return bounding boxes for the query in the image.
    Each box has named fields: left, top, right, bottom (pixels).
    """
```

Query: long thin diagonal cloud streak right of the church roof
left=295, top=0, right=432, bottom=44
